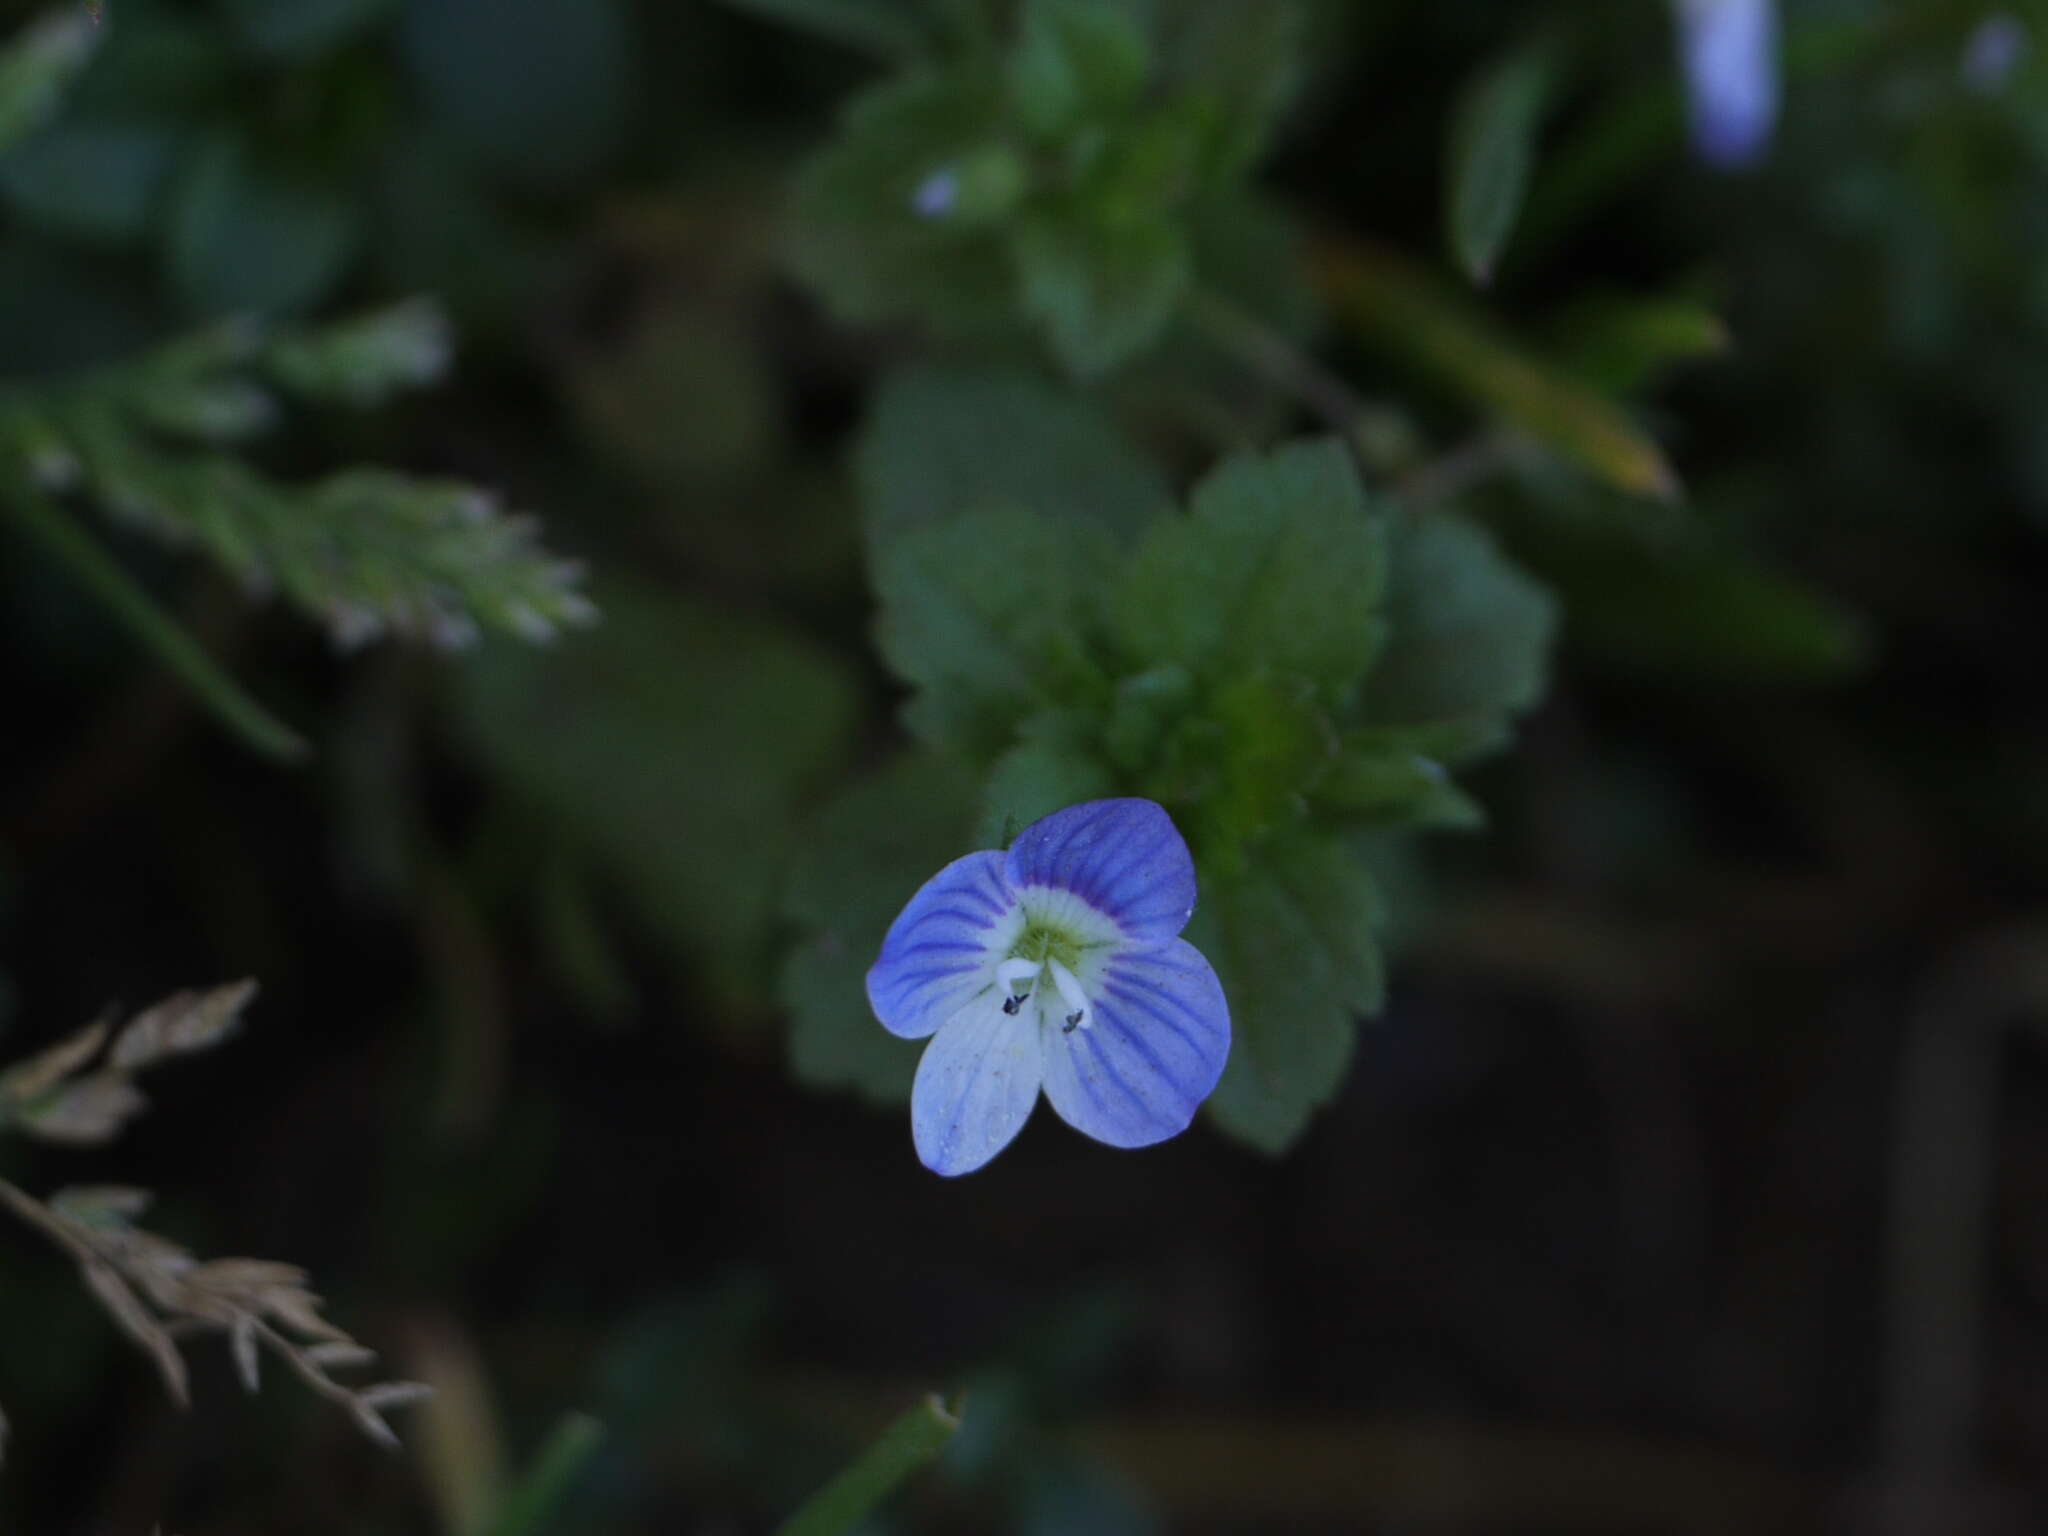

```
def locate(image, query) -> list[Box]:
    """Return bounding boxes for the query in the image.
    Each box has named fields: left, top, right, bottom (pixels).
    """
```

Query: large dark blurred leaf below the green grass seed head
left=453, top=582, right=858, bottom=997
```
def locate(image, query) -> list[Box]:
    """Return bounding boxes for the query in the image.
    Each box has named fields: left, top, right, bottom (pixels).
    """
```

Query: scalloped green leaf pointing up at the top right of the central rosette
left=1116, top=438, right=1386, bottom=698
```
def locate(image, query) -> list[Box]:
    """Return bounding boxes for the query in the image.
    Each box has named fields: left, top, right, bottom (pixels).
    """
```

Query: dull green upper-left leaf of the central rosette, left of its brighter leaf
left=874, top=508, right=1112, bottom=756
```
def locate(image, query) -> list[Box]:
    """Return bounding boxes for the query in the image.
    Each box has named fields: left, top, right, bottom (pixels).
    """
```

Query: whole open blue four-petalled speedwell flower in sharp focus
left=868, top=801, right=1231, bottom=1174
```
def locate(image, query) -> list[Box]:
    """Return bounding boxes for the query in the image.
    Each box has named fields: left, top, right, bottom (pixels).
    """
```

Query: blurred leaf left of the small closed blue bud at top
left=784, top=68, right=1016, bottom=332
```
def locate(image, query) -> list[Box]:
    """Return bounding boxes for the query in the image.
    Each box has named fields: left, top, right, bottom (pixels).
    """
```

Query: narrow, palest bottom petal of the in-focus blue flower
left=909, top=995, right=1042, bottom=1176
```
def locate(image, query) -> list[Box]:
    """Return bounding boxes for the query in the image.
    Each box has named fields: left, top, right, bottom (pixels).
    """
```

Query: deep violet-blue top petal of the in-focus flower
left=1004, top=801, right=1194, bottom=944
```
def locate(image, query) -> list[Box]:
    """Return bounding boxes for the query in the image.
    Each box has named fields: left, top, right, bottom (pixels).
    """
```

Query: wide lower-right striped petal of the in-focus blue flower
left=1044, top=938, right=1231, bottom=1147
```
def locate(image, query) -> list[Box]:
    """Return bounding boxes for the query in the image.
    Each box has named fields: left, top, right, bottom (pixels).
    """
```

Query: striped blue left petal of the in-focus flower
left=868, top=852, right=1024, bottom=1040
